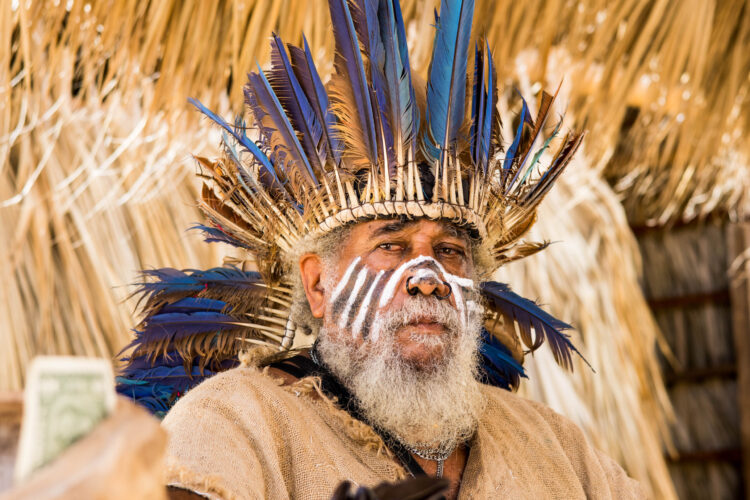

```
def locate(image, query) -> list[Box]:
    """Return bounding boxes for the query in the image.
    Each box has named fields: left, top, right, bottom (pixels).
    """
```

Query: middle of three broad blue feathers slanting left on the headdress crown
left=269, top=33, right=326, bottom=172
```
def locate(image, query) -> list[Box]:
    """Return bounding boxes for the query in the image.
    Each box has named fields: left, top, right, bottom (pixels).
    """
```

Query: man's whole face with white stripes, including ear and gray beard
left=300, top=220, right=484, bottom=449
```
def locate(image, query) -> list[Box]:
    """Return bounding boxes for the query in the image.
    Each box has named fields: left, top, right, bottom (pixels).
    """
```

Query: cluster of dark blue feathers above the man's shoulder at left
left=117, top=267, right=254, bottom=416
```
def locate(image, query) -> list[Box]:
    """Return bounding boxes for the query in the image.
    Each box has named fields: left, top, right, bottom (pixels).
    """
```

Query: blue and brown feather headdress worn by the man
left=116, top=0, right=583, bottom=414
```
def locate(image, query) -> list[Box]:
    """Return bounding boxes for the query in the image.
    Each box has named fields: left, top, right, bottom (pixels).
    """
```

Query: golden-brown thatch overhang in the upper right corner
left=470, top=0, right=750, bottom=225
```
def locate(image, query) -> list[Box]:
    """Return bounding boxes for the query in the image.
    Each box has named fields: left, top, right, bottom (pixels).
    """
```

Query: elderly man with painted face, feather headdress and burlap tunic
left=119, top=0, right=642, bottom=499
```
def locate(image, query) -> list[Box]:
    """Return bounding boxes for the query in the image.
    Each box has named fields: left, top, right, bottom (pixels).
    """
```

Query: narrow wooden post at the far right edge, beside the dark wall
left=727, top=222, right=750, bottom=498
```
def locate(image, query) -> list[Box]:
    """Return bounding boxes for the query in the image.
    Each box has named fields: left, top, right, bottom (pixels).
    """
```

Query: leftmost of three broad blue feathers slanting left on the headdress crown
left=248, top=66, right=319, bottom=186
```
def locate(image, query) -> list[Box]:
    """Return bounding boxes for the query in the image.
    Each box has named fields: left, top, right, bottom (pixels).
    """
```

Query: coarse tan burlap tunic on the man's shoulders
left=163, top=367, right=644, bottom=500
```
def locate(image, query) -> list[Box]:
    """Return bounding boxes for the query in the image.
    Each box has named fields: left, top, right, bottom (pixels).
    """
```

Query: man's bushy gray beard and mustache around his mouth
left=317, top=297, right=485, bottom=451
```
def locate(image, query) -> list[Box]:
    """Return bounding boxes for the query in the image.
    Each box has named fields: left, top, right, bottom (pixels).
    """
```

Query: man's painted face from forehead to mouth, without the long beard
left=323, top=220, right=477, bottom=366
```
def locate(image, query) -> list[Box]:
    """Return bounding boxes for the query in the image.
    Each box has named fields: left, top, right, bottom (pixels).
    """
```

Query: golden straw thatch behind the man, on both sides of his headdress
left=5, top=0, right=750, bottom=497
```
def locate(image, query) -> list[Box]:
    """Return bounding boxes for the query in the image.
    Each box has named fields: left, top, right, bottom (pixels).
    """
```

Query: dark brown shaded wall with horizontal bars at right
left=638, top=224, right=746, bottom=499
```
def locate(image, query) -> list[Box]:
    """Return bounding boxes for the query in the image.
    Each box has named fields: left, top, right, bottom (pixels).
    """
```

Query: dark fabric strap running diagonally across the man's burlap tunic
left=269, top=354, right=426, bottom=477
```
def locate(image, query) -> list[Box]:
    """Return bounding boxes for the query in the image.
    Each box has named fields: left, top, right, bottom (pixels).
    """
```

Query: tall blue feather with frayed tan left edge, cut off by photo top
left=328, top=0, right=378, bottom=165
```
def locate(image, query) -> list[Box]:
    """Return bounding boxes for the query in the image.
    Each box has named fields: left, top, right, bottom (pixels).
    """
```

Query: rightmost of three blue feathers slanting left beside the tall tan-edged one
left=289, top=35, right=342, bottom=166
